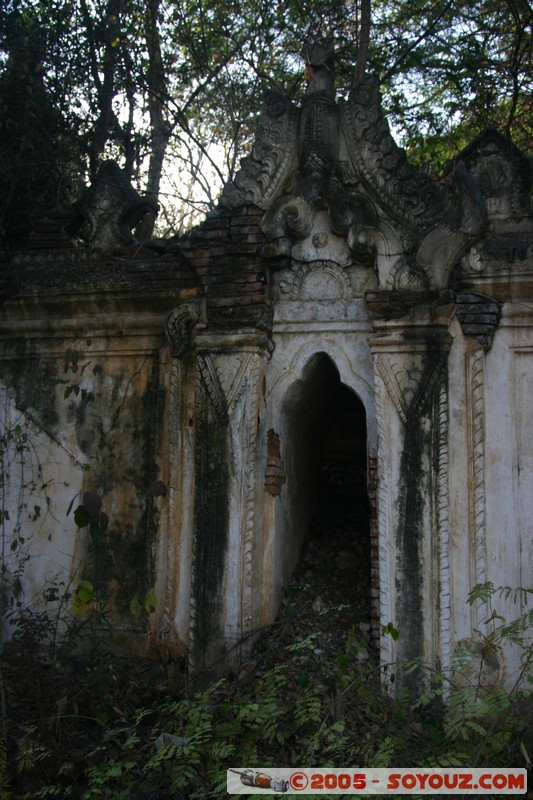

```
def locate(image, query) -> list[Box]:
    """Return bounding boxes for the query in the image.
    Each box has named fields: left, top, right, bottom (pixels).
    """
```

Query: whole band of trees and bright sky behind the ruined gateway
left=0, top=0, right=533, bottom=246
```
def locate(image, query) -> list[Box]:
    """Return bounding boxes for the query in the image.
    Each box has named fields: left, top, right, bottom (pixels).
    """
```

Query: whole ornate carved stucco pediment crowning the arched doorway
left=231, top=57, right=486, bottom=290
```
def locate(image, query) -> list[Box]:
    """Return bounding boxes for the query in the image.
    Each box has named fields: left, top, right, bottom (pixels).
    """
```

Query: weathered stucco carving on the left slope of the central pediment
left=220, top=93, right=298, bottom=209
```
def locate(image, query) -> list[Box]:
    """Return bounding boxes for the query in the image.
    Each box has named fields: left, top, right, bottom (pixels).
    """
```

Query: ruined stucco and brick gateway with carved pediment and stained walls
left=0, top=48, right=533, bottom=692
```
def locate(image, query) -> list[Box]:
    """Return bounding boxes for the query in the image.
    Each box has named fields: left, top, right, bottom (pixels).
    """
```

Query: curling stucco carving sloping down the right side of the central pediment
left=340, top=76, right=486, bottom=288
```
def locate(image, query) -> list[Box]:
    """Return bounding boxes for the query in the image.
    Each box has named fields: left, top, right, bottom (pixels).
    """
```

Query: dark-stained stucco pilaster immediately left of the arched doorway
left=190, top=343, right=262, bottom=673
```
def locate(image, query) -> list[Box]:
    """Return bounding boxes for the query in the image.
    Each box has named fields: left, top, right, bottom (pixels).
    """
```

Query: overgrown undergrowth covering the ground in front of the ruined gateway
left=0, top=586, right=533, bottom=800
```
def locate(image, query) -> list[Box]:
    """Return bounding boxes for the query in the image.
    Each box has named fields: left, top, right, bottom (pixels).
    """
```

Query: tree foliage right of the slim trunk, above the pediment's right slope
left=371, top=0, right=533, bottom=165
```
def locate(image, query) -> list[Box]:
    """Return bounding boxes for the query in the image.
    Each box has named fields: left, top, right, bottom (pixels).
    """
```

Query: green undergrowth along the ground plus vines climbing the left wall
left=0, top=374, right=533, bottom=800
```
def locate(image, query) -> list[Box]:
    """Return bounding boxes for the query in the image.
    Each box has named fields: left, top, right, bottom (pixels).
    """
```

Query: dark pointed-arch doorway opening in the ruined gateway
left=283, top=353, right=371, bottom=639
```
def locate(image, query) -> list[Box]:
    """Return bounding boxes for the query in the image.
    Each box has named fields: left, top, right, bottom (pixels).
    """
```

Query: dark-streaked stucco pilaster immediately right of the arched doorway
left=371, top=311, right=451, bottom=694
